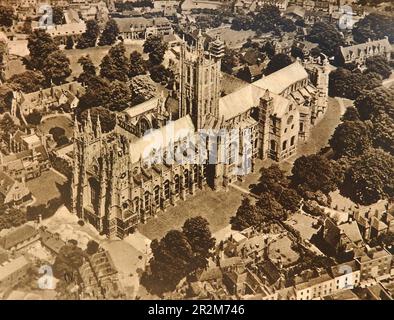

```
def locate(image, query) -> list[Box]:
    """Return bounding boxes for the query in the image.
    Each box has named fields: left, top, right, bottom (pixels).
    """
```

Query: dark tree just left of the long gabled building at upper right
left=307, top=21, right=344, bottom=56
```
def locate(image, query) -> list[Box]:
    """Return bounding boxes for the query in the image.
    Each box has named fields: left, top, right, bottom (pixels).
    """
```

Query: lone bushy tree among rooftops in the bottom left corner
left=52, top=240, right=84, bottom=280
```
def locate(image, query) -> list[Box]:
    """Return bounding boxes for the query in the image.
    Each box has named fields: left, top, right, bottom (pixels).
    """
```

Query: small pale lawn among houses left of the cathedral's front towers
left=26, top=170, right=65, bottom=206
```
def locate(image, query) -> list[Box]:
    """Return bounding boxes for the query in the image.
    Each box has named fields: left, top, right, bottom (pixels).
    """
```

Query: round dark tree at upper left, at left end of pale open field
left=42, top=50, right=71, bottom=85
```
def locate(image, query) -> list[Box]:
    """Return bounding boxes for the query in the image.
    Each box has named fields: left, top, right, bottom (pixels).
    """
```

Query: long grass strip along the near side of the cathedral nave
left=138, top=188, right=243, bottom=240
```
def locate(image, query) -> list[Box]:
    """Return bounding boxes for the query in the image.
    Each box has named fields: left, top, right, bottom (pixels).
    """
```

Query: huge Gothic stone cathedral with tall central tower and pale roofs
left=72, top=35, right=328, bottom=238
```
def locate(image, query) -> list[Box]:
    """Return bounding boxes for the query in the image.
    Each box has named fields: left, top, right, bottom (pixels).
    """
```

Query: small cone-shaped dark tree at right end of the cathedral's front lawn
left=230, top=198, right=262, bottom=231
